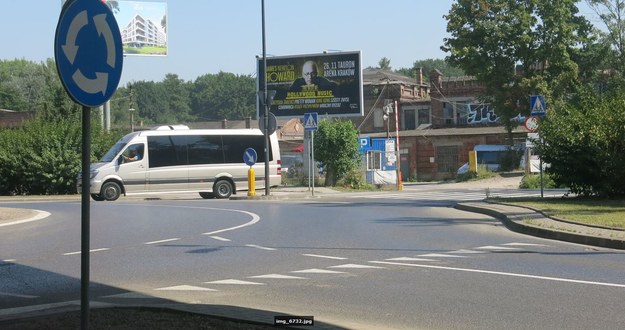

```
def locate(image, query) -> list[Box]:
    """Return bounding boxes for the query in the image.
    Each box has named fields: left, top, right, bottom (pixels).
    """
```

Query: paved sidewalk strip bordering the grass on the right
left=456, top=202, right=625, bottom=250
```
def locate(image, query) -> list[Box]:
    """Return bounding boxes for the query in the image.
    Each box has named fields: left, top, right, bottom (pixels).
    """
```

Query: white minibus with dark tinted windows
left=77, top=125, right=281, bottom=201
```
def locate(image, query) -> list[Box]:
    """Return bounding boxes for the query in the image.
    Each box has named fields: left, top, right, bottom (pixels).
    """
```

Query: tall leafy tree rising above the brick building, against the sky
left=441, top=0, right=593, bottom=139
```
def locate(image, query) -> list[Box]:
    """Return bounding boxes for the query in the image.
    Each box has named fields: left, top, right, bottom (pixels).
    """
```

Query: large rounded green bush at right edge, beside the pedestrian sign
left=536, top=90, right=625, bottom=197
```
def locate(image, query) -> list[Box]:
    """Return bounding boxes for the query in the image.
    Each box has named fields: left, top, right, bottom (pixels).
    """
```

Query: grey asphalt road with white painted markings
left=0, top=187, right=625, bottom=329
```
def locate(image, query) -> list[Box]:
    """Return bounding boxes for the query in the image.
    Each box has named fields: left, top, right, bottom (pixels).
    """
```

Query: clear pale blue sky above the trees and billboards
left=0, top=0, right=604, bottom=86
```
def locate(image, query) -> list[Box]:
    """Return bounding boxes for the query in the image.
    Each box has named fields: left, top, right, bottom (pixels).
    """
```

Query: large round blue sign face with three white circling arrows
left=54, top=0, right=124, bottom=107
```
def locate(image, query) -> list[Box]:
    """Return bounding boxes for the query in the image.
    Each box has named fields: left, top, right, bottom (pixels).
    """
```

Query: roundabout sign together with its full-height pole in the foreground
left=54, top=0, right=123, bottom=329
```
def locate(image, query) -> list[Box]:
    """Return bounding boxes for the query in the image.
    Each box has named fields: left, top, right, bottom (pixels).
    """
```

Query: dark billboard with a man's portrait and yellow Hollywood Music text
left=257, top=52, right=364, bottom=117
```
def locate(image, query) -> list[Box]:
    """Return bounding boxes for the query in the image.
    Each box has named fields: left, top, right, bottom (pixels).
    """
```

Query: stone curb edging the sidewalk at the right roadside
left=455, top=203, right=625, bottom=250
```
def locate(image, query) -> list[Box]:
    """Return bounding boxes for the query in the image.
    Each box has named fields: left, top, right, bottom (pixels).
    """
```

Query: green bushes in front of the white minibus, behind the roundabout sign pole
left=0, top=117, right=120, bottom=195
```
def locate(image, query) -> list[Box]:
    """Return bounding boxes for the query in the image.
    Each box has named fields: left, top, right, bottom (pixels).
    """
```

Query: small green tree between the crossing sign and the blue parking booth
left=315, top=119, right=359, bottom=186
